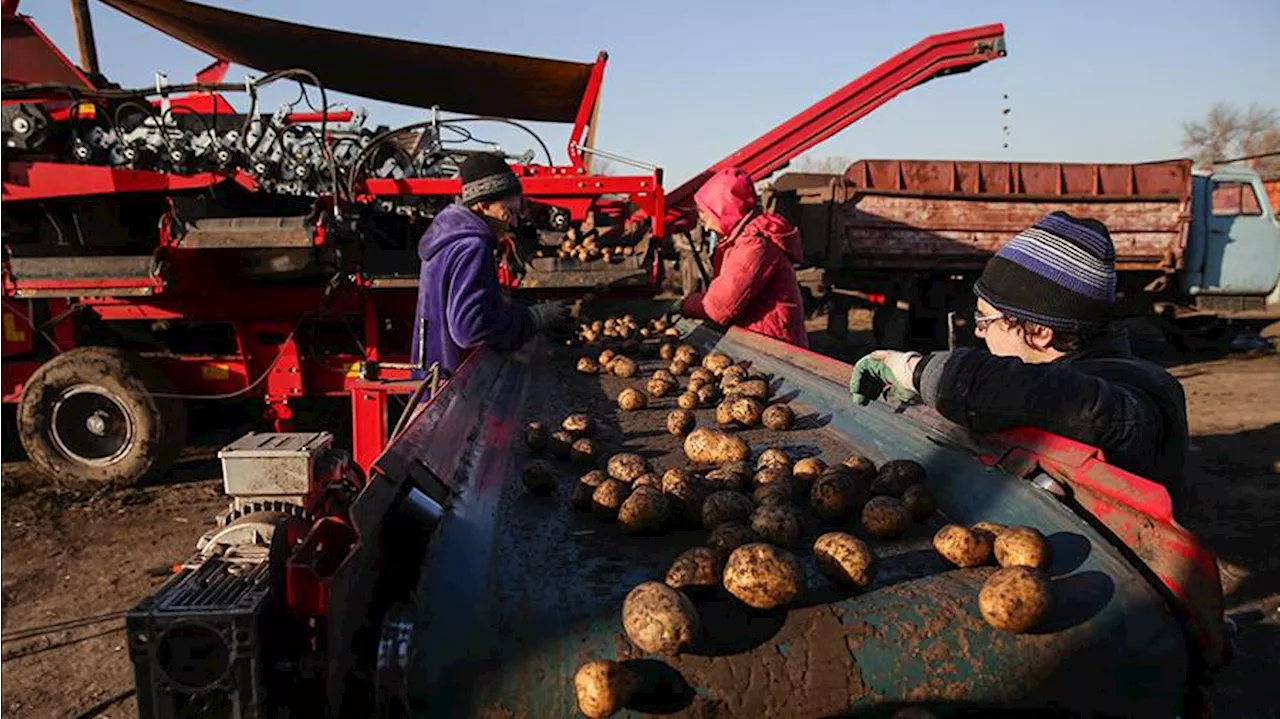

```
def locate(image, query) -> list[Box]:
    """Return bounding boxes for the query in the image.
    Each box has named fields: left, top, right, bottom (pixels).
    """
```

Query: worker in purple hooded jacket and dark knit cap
left=410, top=152, right=568, bottom=379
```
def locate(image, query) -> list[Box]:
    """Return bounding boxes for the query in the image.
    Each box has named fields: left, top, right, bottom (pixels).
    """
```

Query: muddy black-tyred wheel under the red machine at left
left=18, top=347, right=187, bottom=485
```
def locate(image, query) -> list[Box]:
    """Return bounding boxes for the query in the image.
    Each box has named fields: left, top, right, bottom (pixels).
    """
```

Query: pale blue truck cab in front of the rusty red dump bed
left=1180, top=168, right=1280, bottom=308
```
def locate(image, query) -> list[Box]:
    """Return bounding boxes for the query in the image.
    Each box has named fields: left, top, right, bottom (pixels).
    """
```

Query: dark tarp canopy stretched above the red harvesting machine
left=101, top=0, right=591, bottom=123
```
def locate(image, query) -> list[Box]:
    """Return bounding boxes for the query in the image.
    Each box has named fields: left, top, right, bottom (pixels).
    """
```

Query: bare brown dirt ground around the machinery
left=0, top=317, right=1280, bottom=718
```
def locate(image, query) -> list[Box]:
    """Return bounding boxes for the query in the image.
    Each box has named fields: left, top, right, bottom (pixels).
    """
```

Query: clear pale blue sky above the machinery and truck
left=20, top=0, right=1280, bottom=188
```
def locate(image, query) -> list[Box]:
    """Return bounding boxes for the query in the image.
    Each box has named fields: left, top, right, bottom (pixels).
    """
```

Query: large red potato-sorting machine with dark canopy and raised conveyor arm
left=0, top=0, right=1004, bottom=482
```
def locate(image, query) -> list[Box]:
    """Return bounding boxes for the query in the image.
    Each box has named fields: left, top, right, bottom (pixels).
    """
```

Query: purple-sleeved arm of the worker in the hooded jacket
left=445, top=242, right=534, bottom=349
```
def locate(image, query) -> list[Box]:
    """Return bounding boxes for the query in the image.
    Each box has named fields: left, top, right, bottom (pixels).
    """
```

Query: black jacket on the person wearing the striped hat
left=915, top=333, right=1189, bottom=516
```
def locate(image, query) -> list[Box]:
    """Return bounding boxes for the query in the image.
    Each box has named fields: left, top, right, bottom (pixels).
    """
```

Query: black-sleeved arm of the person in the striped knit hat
left=914, top=348, right=1164, bottom=446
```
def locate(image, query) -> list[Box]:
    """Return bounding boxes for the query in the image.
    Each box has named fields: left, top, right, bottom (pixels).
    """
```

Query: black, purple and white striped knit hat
left=973, top=211, right=1116, bottom=331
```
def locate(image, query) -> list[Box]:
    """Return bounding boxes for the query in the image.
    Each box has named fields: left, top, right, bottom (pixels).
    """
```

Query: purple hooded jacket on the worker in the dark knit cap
left=410, top=205, right=534, bottom=377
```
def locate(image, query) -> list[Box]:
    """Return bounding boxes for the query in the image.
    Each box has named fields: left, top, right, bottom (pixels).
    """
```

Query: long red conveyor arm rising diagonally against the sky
left=667, top=23, right=1005, bottom=221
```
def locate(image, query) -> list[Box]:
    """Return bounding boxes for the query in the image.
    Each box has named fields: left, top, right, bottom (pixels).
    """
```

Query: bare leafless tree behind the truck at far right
left=1183, top=102, right=1280, bottom=173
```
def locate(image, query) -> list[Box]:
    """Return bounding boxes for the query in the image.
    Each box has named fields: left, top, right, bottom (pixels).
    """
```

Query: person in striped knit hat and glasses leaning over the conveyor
left=849, top=211, right=1189, bottom=510
